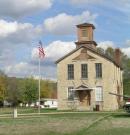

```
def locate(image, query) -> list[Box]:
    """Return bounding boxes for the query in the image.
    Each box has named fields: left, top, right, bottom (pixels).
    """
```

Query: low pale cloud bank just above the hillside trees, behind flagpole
left=3, top=62, right=56, bottom=79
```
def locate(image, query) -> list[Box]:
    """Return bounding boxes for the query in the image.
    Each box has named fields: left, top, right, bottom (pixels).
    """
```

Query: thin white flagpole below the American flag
left=38, top=57, right=41, bottom=114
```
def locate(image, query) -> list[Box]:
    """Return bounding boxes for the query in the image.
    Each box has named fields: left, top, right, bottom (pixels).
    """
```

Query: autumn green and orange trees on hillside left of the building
left=0, top=71, right=57, bottom=106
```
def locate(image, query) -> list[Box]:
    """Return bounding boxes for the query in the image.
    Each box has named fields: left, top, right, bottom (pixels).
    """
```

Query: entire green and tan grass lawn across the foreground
left=0, top=113, right=130, bottom=135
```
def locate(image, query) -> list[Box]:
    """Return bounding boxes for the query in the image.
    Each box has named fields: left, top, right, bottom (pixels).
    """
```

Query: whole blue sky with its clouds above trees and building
left=0, top=0, right=130, bottom=79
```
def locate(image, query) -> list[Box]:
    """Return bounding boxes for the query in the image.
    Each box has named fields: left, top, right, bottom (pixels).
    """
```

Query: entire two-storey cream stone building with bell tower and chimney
left=56, top=23, right=123, bottom=111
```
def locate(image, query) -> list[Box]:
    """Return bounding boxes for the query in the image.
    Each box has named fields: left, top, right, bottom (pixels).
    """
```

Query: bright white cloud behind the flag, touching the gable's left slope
left=32, top=41, right=76, bottom=62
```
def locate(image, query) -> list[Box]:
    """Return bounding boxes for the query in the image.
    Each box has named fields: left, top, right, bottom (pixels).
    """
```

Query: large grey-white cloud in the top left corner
left=0, top=0, right=53, bottom=17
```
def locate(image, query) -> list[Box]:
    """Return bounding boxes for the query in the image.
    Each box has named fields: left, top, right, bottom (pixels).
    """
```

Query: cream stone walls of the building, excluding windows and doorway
left=57, top=48, right=123, bottom=111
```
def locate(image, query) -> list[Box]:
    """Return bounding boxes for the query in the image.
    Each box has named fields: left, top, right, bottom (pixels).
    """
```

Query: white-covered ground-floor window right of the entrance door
left=95, top=86, right=103, bottom=101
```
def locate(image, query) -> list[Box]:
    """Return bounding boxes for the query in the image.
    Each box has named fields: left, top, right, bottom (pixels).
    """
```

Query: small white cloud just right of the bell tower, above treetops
left=98, top=41, right=116, bottom=50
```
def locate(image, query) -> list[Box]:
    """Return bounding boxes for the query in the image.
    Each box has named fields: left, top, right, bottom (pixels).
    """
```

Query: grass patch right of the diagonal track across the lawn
left=85, top=114, right=130, bottom=135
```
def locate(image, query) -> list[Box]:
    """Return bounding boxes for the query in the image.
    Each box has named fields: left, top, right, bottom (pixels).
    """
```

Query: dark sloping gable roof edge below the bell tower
left=55, top=46, right=122, bottom=69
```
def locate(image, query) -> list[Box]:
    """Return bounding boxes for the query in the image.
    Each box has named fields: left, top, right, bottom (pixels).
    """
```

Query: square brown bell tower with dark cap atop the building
left=75, top=23, right=97, bottom=49
